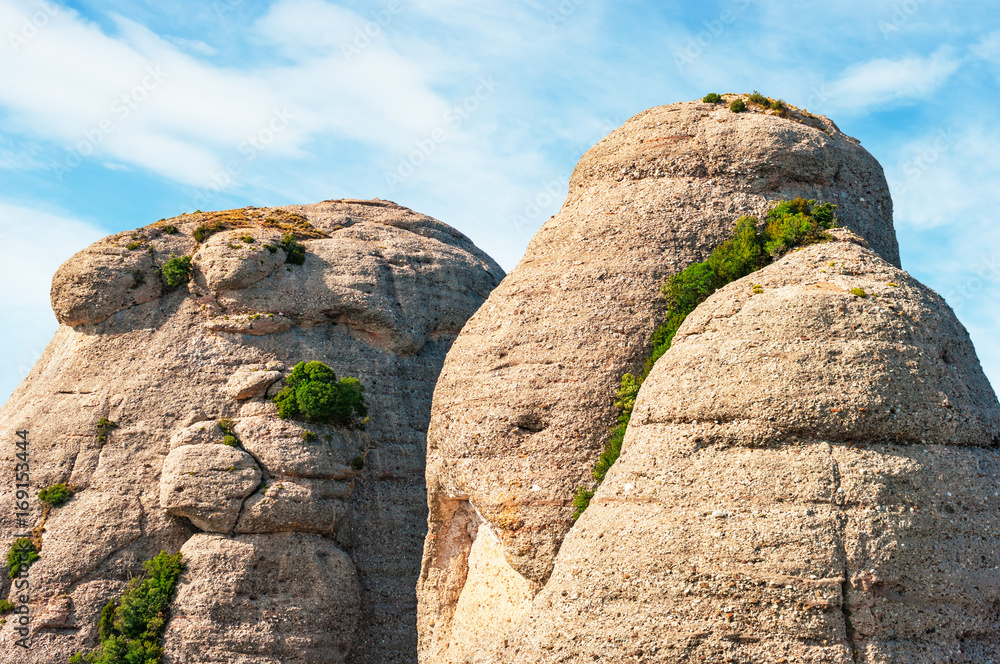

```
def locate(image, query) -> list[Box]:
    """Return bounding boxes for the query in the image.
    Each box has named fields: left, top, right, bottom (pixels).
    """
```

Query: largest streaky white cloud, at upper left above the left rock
left=0, top=0, right=460, bottom=186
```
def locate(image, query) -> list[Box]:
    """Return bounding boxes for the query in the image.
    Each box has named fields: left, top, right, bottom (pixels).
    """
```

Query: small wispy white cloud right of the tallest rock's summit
left=825, top=47, right=962, bottom=111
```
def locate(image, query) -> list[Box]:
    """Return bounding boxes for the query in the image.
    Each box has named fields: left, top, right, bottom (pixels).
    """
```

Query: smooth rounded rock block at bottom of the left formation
left=163, top=533, right=361, bottom=664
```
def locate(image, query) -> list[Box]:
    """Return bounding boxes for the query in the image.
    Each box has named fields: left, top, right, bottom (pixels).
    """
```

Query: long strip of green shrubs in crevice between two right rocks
left=573, top=198, right=837, bottom=520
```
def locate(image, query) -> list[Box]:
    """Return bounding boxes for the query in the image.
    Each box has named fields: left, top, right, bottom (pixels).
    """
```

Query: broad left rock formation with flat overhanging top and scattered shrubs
left=0, top=200, right=503, bottom=664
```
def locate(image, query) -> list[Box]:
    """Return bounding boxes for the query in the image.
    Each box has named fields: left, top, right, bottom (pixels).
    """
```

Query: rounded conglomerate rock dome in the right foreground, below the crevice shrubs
left=482, top=233, right=1000, bottom=664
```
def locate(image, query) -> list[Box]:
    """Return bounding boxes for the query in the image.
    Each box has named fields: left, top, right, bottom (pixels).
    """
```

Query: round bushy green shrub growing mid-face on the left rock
left=274, top=362, right=368, bottom=425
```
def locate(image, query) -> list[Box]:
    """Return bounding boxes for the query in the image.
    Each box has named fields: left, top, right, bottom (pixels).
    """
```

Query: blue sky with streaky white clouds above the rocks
left=0, top=0, right=1000, bottom=399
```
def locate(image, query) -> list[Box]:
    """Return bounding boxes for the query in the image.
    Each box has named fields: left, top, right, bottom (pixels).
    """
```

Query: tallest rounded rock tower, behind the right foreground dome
left=418, top=96, right=898, bottom=662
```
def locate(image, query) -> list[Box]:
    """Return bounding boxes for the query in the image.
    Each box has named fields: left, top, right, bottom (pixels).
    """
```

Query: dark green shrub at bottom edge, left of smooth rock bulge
left=70, top=551, right=184, bottom=664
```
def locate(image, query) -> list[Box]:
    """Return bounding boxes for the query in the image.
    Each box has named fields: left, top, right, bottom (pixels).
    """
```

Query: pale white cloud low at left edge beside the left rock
left=0, top=201, right=107, bottom=401
